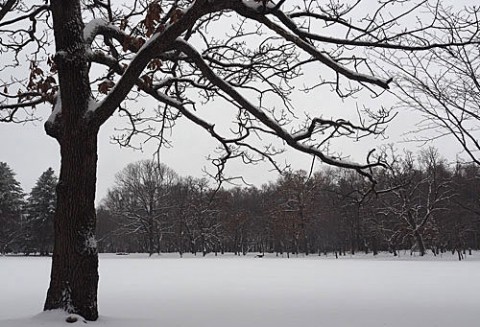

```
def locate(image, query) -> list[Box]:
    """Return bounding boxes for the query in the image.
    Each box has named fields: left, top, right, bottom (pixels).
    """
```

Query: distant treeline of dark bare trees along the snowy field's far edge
left=0, top=148, right=480, bottom=258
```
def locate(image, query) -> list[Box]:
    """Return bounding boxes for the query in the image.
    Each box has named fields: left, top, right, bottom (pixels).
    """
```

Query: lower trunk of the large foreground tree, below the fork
left=44, top=135, right=98, bottom=320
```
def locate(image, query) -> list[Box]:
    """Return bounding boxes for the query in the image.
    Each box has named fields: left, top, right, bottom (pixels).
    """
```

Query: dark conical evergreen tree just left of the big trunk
left=27, top=168, right=57, bottom=255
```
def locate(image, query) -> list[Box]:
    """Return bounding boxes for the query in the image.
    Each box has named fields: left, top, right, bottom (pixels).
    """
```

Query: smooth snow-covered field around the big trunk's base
left=0, top=253, right=480, bottom=327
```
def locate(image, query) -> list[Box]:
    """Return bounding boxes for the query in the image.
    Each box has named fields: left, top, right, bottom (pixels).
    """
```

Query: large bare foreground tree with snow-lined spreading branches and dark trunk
left=0, top=0, right=471, bottom=320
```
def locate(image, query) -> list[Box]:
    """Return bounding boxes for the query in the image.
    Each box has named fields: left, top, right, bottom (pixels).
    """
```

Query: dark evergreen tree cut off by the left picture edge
left=0, top=162, right=24, bottom=254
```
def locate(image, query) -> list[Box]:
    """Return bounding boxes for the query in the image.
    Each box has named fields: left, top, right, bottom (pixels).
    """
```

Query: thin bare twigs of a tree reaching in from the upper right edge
left=388, top=9, right=480, bottom=165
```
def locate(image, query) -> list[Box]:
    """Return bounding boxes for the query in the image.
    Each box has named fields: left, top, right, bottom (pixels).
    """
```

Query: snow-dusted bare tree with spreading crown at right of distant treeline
left=377, top=148, right=454, bottom=256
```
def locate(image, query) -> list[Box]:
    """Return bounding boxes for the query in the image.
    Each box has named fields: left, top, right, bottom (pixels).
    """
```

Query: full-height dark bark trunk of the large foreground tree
left=44, top=0, right=98, bottom=320
